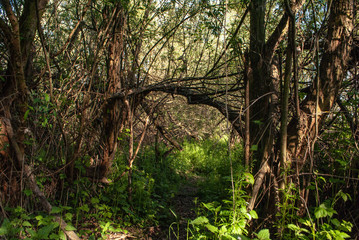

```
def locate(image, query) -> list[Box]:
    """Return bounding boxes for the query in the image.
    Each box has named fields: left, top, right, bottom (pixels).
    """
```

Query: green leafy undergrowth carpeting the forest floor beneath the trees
left=0, top=139, right=352, bottom=240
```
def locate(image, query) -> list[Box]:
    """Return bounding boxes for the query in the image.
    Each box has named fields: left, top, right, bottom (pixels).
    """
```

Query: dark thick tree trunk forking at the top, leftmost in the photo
left=0, top=0, right=48, bottom=202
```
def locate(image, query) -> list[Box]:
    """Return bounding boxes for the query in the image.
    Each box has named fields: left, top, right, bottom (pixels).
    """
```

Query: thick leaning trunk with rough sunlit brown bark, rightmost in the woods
left=288, top=0, right=353, bottom=171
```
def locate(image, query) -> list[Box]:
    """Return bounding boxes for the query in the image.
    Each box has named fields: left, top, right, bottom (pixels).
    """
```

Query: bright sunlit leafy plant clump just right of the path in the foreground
left=188, top=173, right=270, bottom=240
